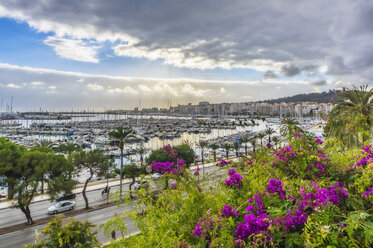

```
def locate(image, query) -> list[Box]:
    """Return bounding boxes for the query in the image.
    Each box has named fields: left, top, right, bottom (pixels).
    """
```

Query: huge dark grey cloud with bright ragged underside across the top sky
left=0, top=0, right=373, bottom=87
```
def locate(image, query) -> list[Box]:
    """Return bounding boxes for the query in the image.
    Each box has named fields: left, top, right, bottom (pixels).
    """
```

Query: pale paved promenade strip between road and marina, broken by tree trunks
left=0, top=157, right=239, bottom=210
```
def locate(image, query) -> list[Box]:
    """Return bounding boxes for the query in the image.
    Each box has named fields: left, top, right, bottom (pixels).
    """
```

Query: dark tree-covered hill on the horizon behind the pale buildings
left=260, top=90, right=341, bottom=104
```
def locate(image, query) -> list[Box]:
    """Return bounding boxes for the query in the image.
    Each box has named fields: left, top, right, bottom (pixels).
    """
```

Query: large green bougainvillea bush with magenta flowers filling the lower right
left=111, top=135, right=373, bottom=248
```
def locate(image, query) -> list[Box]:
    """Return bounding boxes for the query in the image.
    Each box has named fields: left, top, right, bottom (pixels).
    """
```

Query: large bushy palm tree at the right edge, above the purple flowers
left=325, top=85, right=373, bottom=145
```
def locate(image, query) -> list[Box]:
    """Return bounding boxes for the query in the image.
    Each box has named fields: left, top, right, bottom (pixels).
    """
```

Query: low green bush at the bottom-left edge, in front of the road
left=26, top=217, right=100, bottom=248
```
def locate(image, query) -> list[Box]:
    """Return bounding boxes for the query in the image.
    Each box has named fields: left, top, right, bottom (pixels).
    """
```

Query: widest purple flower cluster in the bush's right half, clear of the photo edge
left=298, top=183, right=348, bottom=209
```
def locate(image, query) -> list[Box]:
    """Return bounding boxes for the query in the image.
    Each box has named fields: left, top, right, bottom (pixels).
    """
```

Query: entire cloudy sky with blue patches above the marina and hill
left=0, top=0, right=373, bottom=110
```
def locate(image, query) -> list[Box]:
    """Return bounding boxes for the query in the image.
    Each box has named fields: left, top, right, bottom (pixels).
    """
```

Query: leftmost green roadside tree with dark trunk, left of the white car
left=0, top=140, right=75, bottom=224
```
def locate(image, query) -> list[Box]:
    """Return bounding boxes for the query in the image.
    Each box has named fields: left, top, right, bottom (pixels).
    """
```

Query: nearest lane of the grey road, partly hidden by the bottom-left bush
left=0, top=203, right=138, bottom=248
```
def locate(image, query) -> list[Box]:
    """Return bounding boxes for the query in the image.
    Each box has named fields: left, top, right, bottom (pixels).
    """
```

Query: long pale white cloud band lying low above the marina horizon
left=0, top=64, right=333, bottom=110
